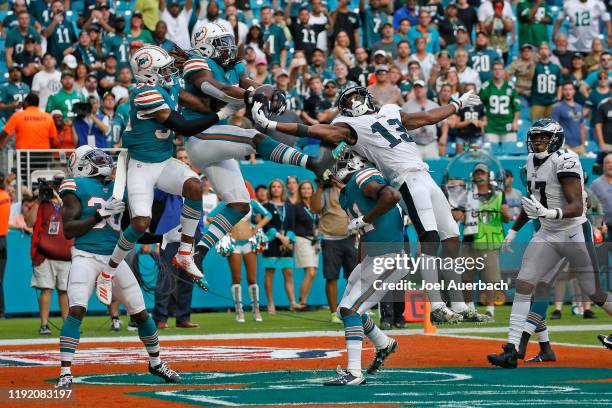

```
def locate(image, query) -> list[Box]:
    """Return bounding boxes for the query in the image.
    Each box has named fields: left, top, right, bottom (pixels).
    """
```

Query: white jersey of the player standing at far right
left=526, top=149, right=587, bottom=231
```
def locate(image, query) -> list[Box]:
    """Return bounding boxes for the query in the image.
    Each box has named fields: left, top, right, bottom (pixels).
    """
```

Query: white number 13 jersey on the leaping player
left=332, top=104, right=429, bottom=186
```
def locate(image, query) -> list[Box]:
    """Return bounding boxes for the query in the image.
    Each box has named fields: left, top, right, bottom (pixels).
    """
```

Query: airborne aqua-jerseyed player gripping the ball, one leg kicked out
left=183, top=23, right=334, bottom=278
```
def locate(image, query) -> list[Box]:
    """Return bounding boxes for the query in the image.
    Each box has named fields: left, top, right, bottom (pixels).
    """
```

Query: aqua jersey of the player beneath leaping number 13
left=340, top=167, right=404, bottom=255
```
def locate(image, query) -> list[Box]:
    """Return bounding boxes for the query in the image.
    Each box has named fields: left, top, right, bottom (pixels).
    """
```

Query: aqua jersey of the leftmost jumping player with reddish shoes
left=123, top=84, right=181, bottom=163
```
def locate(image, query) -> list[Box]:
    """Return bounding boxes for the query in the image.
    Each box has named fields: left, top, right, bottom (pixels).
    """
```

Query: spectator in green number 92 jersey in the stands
left=480, top=61, right=521, bottom=143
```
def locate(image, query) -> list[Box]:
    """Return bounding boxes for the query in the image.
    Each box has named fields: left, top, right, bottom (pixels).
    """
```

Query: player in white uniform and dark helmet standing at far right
left=487, top=119, right=612, bottom=368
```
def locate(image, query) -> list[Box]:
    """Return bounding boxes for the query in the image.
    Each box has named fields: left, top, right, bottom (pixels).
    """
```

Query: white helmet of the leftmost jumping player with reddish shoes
left=130, top=45, right=178, bottom=88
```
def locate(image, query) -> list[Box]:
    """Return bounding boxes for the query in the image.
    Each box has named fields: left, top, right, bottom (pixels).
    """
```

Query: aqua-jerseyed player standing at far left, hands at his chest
left=56, top=146, right=180, bottom=388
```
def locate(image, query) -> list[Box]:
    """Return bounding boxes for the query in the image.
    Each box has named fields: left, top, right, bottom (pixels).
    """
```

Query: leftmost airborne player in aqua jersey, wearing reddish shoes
left=96, top=45, right=239, bottom=305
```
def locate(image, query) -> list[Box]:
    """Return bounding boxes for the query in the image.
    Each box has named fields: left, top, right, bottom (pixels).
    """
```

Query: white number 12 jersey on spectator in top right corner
left=560, top=0, right=610, bottom=52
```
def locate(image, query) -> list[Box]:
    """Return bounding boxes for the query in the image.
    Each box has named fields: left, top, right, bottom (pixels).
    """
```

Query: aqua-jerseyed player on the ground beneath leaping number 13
left=324, top=152, right=408, bottom=385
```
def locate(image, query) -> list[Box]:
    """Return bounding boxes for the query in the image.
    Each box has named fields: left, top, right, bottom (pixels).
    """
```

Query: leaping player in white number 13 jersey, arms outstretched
left=251, top=86, right=489, bottom=323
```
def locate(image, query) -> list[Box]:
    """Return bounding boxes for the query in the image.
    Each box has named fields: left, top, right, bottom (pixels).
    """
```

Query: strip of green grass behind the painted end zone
left=0, top=305, right=612, bottom=345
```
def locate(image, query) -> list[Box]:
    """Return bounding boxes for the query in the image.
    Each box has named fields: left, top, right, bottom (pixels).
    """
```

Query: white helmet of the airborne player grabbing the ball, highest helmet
left=191, top=23, right=238, bottom=66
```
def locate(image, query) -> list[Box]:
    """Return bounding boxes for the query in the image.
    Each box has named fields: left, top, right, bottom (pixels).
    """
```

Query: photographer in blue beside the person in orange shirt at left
left=72, top=96, right=109, bottom=149
